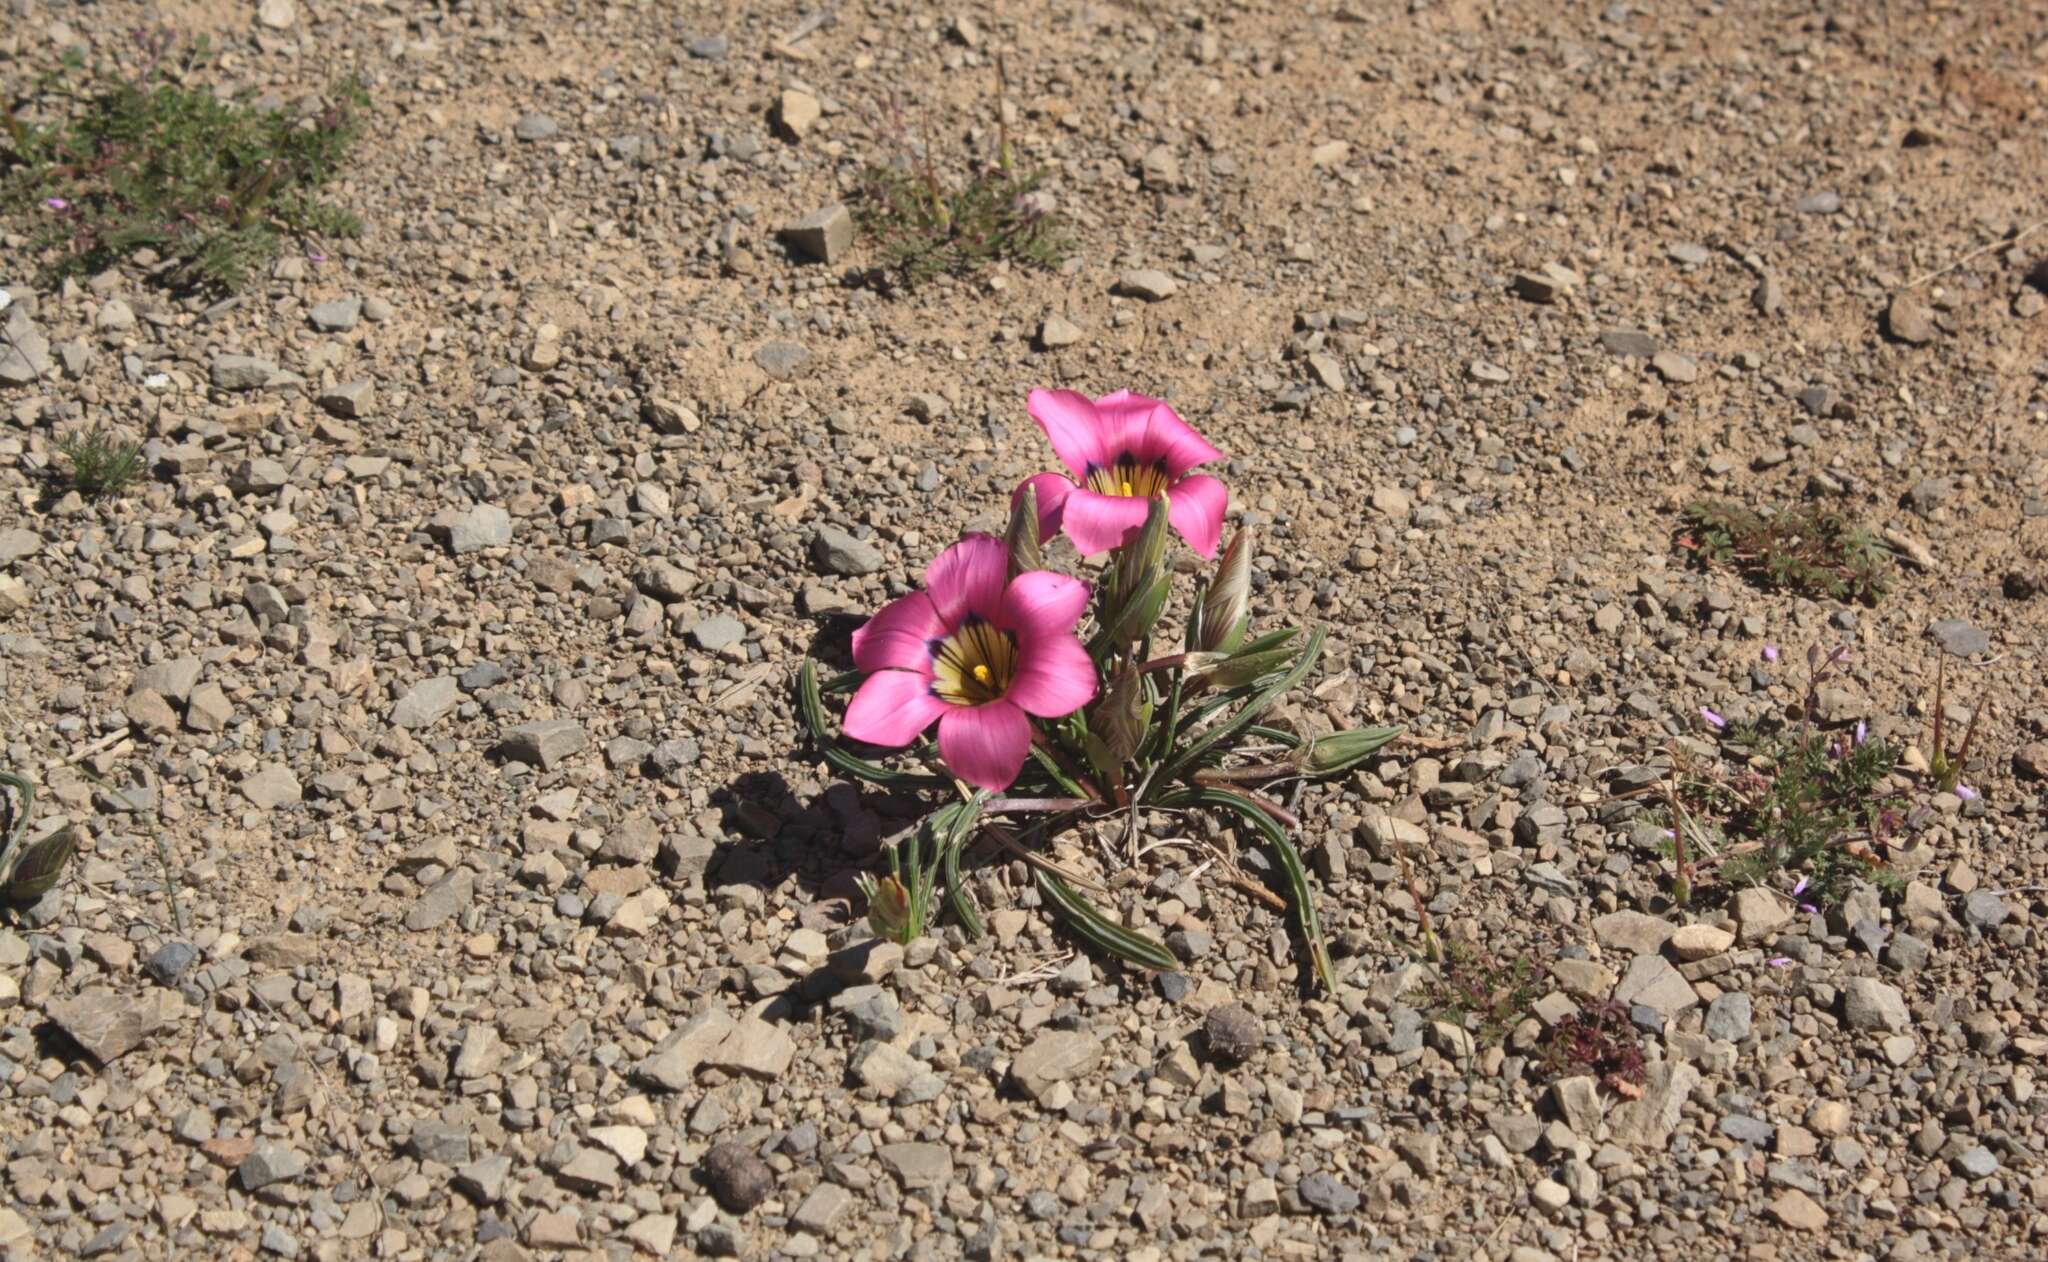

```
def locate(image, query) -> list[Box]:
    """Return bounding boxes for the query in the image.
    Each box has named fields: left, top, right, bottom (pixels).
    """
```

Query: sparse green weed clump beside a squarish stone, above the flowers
left=852, top=80, right=1067, bottom=289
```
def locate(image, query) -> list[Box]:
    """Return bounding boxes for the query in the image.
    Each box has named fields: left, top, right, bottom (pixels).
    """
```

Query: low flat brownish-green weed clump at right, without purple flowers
left=1677, top=500, right=1892, bottom=604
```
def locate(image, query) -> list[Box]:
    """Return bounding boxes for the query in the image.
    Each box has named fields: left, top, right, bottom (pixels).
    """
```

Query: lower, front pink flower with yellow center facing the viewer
left=846, top=535, right=1096, bottom=791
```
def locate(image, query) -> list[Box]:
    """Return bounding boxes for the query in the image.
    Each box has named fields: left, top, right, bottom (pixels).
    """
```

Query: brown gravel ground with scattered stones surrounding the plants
left=0, top=0, right=2048, bottom=1262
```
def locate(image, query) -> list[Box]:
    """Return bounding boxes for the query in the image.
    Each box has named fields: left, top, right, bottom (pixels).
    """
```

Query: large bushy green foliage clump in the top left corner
left=0, top=31, right=369, bottom=291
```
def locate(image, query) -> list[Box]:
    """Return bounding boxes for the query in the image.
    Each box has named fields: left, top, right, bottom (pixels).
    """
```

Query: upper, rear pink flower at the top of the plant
left=1012, top=389, right=1229, bottom=557
